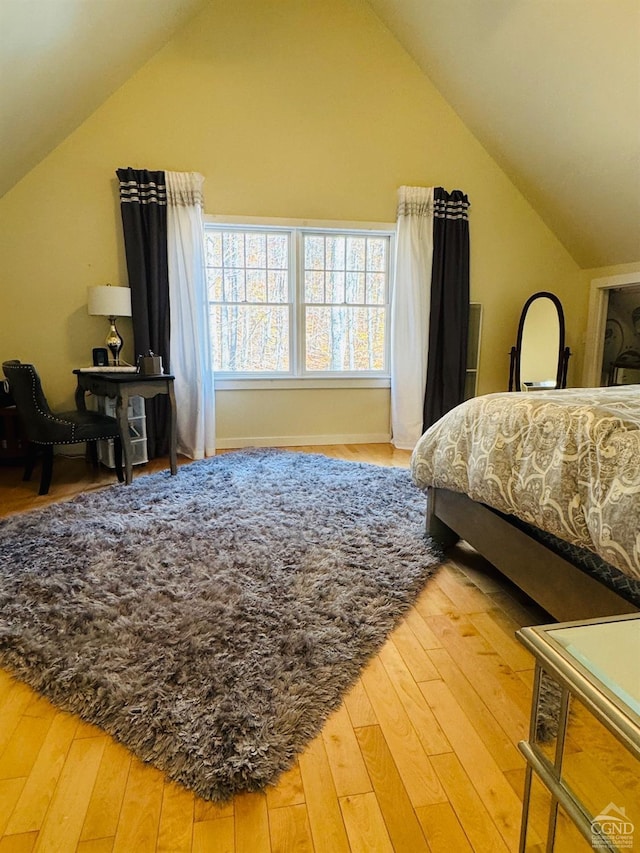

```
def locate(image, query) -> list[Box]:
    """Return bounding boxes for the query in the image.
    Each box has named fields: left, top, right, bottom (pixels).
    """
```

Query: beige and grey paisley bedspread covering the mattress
left=411, top=385, right=640, bottom=581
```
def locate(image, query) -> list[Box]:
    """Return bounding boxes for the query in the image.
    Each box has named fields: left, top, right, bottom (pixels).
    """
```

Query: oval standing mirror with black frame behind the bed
left=509, top=290, right=570, bottom=391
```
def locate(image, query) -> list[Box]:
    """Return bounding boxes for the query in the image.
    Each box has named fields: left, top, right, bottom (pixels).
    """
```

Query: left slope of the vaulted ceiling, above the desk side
left=0, top=0, right=208, bottom=196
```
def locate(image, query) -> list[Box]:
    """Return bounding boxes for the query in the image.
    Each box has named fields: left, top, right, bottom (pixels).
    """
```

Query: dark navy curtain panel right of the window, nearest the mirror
left=423, top=187, right=469, bottom=430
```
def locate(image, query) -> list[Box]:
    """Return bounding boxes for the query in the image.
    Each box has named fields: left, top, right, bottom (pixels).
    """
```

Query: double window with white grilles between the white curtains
left=205, top=223, right=392, bottom=378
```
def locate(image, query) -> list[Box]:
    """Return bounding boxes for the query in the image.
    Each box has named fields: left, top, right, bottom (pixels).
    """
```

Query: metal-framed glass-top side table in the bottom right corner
left=516, top=613, right=640, bottom=853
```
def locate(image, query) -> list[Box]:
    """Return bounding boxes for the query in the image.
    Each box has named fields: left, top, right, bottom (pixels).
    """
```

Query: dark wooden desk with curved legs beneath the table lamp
left=73, top=370, right=178, bottom=485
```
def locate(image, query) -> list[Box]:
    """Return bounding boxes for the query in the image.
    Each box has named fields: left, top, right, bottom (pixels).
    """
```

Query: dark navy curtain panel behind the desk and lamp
left=116, top=168, right=171, bottom=459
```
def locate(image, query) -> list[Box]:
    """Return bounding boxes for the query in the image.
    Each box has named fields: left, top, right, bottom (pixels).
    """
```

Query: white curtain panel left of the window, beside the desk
left=165, top=172, right=216, bottom=459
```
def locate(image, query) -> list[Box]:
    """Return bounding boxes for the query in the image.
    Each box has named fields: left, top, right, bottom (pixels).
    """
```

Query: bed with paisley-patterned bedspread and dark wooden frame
left=411, top=385, right=640, bottom=621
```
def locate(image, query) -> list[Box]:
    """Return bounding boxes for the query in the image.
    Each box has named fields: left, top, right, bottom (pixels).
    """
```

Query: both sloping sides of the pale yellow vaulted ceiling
left=0, top=0, right=640, bottom=268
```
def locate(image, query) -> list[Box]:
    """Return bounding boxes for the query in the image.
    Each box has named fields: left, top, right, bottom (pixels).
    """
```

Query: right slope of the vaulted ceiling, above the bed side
left=369, top=0, right=640, bottom=268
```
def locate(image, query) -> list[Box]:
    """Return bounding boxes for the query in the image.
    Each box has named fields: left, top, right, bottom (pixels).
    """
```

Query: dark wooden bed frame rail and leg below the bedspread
left=427, top=488, right=638, bottom=622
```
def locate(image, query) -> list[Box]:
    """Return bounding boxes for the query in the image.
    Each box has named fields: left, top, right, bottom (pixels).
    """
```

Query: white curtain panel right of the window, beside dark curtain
left=391, top=187, right=433, bottom=450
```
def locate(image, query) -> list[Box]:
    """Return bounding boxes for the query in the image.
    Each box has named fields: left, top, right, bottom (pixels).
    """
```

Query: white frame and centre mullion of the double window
left=203, top=214, right=396, bottom=390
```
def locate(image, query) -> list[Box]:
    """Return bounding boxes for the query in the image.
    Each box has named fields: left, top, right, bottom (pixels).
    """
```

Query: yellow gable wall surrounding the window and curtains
left=0, top=0, right=588, bottom=442
